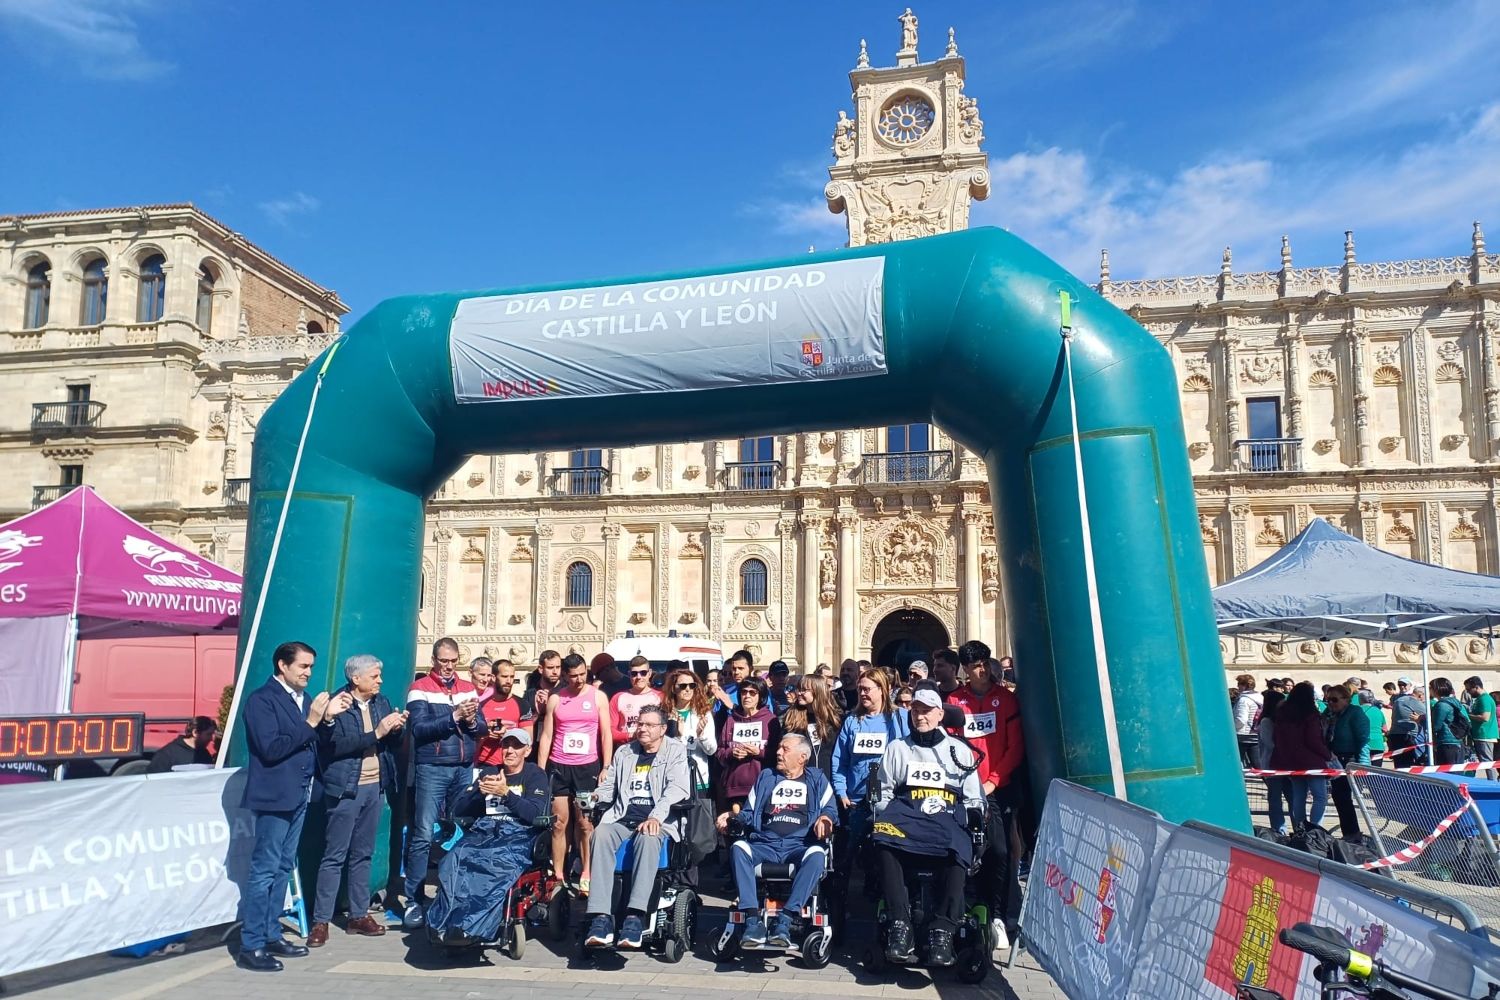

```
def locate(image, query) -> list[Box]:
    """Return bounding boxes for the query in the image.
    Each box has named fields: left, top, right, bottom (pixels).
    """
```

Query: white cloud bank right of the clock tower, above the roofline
left=972, top=103, right=1500, bottom=277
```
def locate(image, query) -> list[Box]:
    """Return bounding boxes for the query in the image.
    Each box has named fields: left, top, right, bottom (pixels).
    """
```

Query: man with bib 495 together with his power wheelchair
left=716, top=733, right=839, bottom=966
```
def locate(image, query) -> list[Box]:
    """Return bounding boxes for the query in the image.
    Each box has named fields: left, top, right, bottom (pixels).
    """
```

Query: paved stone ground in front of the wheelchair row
left=0, top=898, right=1064, bottom=1000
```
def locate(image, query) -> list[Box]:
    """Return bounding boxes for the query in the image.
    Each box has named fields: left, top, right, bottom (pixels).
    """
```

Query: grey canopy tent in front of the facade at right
left=1214, top=517, right=1500, bottom=755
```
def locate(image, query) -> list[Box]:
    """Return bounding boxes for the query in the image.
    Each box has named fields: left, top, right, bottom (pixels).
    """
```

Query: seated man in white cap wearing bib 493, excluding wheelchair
left=873, top=688, right=984, bottom=967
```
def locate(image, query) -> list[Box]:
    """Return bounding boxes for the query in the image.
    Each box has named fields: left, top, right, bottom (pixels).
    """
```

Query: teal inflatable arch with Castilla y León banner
left=234, top=229, right=1250, bottom=875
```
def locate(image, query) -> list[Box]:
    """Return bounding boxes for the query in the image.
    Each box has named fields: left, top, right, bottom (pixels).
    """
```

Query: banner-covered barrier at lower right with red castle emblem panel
left=1022, top=781, right=1500, bottom=1000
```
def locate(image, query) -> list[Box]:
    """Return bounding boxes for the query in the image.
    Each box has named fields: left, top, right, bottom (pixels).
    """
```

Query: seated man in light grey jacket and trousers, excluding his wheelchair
left=584, top=705, right=693, bottom=948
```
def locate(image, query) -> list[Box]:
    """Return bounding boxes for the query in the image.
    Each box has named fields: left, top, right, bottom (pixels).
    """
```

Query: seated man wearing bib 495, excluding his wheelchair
left=719, top=733, right=839, bottom=948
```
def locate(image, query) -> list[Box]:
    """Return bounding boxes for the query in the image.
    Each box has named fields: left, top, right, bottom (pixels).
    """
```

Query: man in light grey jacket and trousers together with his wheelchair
left=584, top=705, right=698, bottom=961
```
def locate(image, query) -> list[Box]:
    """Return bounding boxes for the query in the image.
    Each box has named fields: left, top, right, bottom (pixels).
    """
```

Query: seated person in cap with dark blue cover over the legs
left=428, top=727, right=552, bottom=942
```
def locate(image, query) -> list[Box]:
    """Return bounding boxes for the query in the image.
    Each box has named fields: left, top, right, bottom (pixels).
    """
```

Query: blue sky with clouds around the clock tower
left=0, top=0, right=1500, bottom=316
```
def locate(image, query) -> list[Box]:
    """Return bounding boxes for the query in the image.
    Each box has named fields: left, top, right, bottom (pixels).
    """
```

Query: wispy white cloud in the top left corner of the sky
left=0, top=0, right=173, bottom=79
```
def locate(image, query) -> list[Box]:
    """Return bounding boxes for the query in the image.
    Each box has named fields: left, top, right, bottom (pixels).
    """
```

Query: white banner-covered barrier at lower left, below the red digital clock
left=0, top=769, right=255, bottom=976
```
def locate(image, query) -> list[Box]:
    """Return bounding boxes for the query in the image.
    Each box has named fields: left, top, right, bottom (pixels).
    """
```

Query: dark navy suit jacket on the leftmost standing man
left=242, top=678, right=318, bottom=813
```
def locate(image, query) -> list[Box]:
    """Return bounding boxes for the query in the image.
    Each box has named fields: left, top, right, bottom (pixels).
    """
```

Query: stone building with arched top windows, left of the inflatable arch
left=0, top=205, right=348, bottom=554
